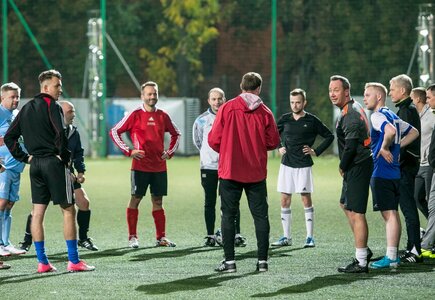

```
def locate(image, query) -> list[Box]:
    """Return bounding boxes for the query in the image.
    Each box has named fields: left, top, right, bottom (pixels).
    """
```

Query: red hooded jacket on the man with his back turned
left=208, top=93, right=280, bottom=183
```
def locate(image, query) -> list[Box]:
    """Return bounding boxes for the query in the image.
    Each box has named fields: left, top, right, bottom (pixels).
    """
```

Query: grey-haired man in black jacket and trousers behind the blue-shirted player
left=389, top=74, right=421, bottom=263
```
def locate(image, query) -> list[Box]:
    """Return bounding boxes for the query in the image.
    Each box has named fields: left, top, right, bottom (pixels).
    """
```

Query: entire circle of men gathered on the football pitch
left=0, top=70, right=435, bottom=273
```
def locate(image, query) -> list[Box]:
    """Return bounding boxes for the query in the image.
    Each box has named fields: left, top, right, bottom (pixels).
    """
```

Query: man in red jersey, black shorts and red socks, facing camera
left=110, top=81, right=180, bottom=248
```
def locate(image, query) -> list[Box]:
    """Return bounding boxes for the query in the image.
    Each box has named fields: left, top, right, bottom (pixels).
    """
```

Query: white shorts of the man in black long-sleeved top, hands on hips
left=277, top=164, right=313, bottom=194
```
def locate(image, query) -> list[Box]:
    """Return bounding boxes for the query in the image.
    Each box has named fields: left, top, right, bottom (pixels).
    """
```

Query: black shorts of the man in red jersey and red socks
left=131, top=170, right=168, bottom=197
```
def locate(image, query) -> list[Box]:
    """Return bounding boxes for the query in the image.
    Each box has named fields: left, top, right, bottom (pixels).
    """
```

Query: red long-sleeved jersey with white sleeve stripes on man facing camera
left=110, top=105, right=180, bottom=172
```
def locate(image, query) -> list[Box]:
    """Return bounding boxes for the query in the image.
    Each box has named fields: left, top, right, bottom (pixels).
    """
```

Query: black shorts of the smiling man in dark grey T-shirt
left=340, top=157, right=373, bottom=214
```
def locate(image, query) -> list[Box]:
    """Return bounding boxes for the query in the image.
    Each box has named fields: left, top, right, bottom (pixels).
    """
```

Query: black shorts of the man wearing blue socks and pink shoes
left=29, top=156, right=74, bottom=205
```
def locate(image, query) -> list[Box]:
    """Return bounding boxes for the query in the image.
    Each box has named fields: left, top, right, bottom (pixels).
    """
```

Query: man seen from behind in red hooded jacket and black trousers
left=208, top=72, right=280, bottom=273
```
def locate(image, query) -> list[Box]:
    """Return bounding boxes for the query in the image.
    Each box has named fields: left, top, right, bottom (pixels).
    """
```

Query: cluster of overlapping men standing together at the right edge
left=329, top=74, right=435, bottom=273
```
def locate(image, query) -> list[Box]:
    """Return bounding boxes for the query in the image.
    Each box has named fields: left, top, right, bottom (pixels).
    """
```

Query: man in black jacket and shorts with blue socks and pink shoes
left=4, top=70, right=95, bottom=273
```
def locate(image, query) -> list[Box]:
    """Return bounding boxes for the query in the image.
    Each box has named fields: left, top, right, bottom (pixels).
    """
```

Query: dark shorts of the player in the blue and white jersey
left=370, top=177, right=400, bottom=211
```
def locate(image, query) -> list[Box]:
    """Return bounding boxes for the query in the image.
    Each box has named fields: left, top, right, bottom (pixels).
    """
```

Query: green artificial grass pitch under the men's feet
left=0, top=157, right=435, bottom=299
